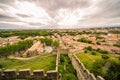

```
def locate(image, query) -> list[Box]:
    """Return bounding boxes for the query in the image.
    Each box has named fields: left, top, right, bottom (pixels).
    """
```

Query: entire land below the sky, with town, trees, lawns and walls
left=0, top=27, right=120, bottom=80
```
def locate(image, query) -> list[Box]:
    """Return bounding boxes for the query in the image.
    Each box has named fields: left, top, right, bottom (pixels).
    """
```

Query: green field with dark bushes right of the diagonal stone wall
left=76, top=51, right=120, bottom=80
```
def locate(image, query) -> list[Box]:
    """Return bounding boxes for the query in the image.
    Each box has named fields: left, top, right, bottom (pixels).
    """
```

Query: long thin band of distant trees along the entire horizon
left=0, top=30, right=110, bottom=39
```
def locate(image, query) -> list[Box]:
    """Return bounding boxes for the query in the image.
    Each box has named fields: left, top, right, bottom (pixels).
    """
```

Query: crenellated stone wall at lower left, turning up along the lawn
left=0, top=50, right=61, bottom=80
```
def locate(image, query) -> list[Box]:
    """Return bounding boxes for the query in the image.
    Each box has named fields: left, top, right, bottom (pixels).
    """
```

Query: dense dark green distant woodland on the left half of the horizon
left=0, top=30, right=53, bottom=39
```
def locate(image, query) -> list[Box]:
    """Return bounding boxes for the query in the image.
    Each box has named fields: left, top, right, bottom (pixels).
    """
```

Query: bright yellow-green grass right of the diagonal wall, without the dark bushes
left=76, top=51, right=118, bottom=70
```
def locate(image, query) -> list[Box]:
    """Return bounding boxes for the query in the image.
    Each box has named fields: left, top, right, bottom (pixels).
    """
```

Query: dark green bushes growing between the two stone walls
left=59, top=54, right=77, bottom=80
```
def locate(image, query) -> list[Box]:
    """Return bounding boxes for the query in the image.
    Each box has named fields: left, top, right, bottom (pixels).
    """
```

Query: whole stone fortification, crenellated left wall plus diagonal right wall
left=0, top=47, right=104, bottom=80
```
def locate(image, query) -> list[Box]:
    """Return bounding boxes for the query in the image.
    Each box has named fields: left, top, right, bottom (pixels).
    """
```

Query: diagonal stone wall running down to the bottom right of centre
left=69, top=55, right=104, bottom=80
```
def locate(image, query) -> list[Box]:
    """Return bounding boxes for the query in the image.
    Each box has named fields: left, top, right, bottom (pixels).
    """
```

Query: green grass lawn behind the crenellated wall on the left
left=0, top=54, right=56, bottom=71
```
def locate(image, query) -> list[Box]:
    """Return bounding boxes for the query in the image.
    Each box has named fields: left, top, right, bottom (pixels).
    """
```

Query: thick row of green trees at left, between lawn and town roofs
left=0, top=40, right=33, bottom=57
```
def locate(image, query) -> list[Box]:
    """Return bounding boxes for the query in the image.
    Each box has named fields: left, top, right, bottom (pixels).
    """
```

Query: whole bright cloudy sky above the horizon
left=0, top=0, right=120, bottom=29
